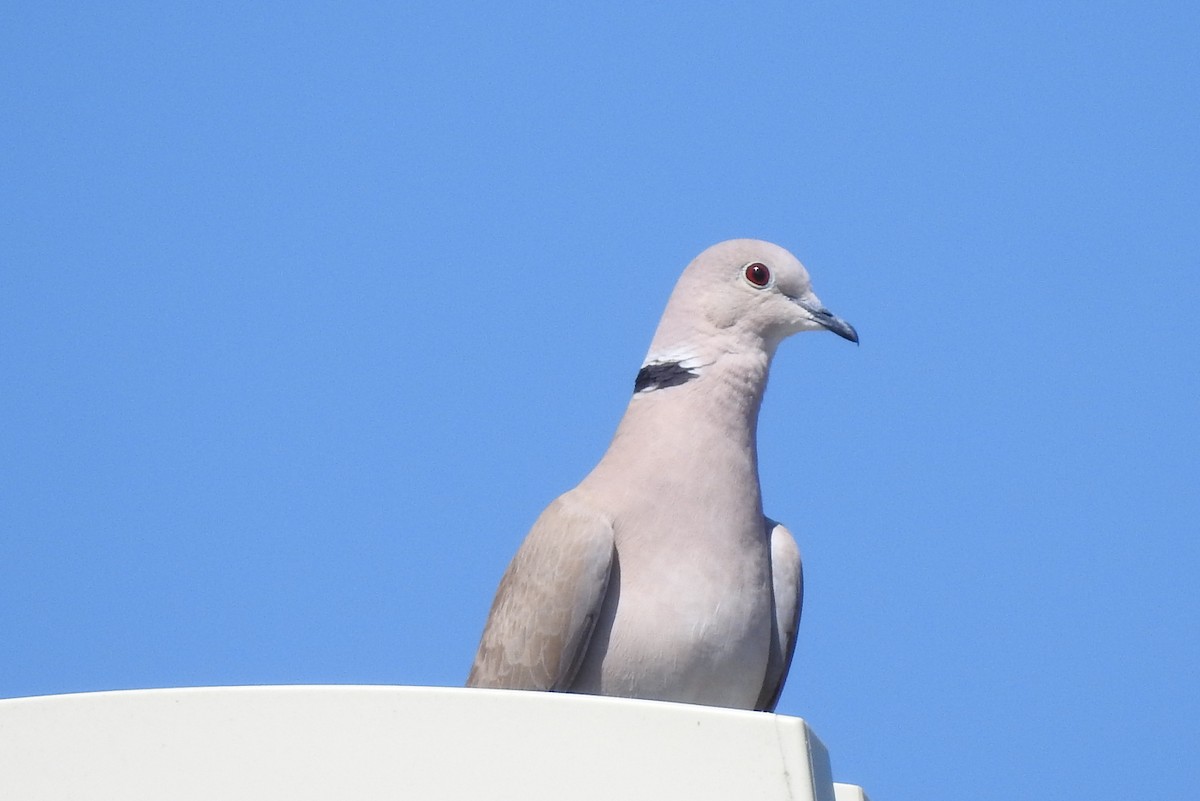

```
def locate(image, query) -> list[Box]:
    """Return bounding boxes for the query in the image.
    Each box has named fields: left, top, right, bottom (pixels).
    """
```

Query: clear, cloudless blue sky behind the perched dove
left=0, top=2, right=1200, bottom=799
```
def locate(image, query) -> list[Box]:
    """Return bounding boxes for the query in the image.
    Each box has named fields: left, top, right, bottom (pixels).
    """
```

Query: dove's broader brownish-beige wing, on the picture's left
left=467, top=493, right=613, bottom=689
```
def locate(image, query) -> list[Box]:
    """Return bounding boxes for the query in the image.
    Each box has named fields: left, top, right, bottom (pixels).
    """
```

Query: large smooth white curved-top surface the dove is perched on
left=0, top=686, right=873, bottom=801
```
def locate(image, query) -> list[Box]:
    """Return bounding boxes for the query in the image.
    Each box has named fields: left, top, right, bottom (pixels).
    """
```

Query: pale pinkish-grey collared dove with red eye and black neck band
left=467, top=239, right=858, bottom=712
